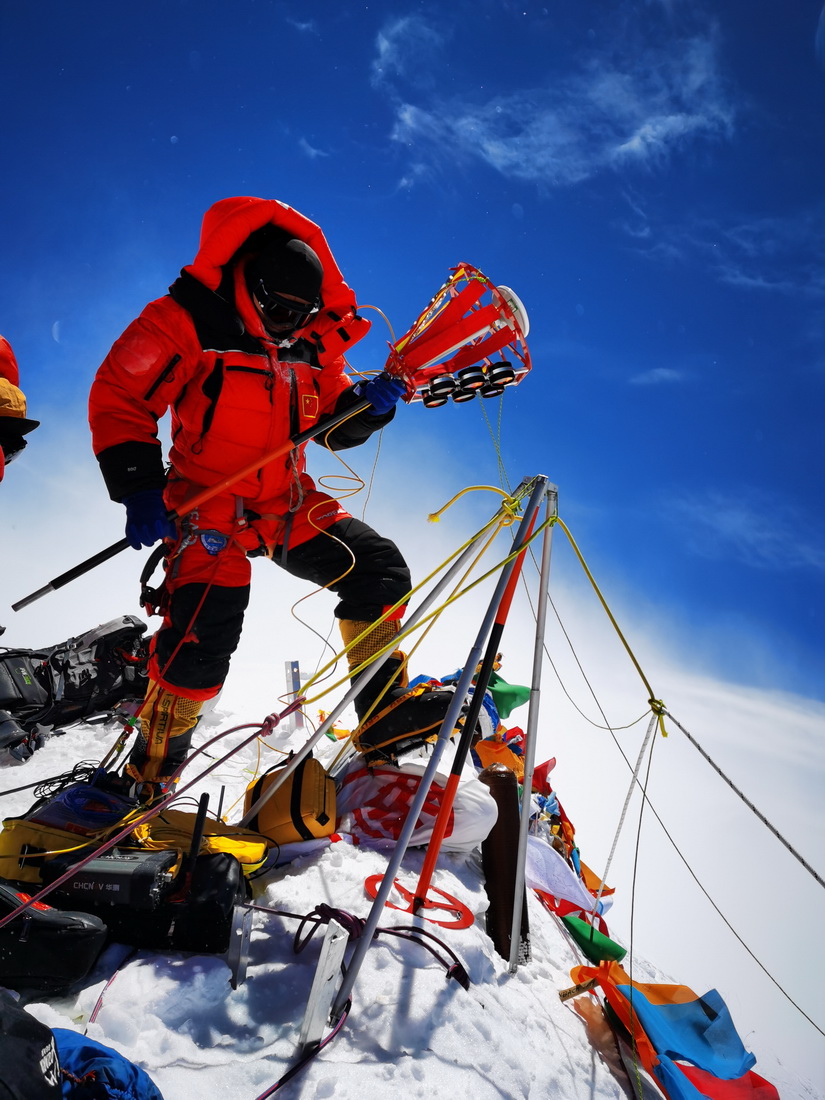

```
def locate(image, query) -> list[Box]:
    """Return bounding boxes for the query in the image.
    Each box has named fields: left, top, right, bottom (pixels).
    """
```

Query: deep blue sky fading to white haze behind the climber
left=0, top=0, right=825, bottom=1079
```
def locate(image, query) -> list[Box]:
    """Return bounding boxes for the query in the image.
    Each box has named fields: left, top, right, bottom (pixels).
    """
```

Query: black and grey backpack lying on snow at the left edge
left=0, top=615, right=149, bottom=761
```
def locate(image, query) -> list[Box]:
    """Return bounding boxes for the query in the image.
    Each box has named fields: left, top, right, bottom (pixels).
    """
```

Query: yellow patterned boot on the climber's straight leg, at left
left=127, top=680, right=204, bottom=800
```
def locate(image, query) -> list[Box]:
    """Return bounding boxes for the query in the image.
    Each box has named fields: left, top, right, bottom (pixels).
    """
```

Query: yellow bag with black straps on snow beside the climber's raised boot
left=243, top=756, right=336, bottom=844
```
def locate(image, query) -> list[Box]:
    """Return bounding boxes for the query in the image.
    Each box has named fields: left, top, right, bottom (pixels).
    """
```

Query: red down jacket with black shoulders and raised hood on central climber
left=89, top=198, right=392, bottom=541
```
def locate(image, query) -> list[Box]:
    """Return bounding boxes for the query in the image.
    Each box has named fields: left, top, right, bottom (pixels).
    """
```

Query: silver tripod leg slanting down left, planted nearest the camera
left=331, top=475, right=547, bottom=1021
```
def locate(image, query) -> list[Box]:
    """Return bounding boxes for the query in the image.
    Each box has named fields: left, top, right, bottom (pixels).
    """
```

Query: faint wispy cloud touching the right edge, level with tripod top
left=664, top=492, right=825, bottom=570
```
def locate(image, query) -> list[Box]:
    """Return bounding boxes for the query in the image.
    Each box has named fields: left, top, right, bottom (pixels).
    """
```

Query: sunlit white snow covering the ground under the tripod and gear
left=0, top=704, right=817, bottom=1100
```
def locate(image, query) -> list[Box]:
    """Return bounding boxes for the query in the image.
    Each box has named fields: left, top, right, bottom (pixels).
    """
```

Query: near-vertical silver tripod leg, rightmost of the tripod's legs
left=509, top=485, right=559, bottom=974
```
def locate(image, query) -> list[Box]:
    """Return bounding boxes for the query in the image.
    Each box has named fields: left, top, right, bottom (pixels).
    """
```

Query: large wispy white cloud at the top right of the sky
left=373, top=17, right=735, bottom=187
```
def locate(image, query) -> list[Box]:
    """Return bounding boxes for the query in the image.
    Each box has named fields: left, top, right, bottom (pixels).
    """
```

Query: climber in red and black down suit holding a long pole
left=89, top=198, right=410, bottom=793
